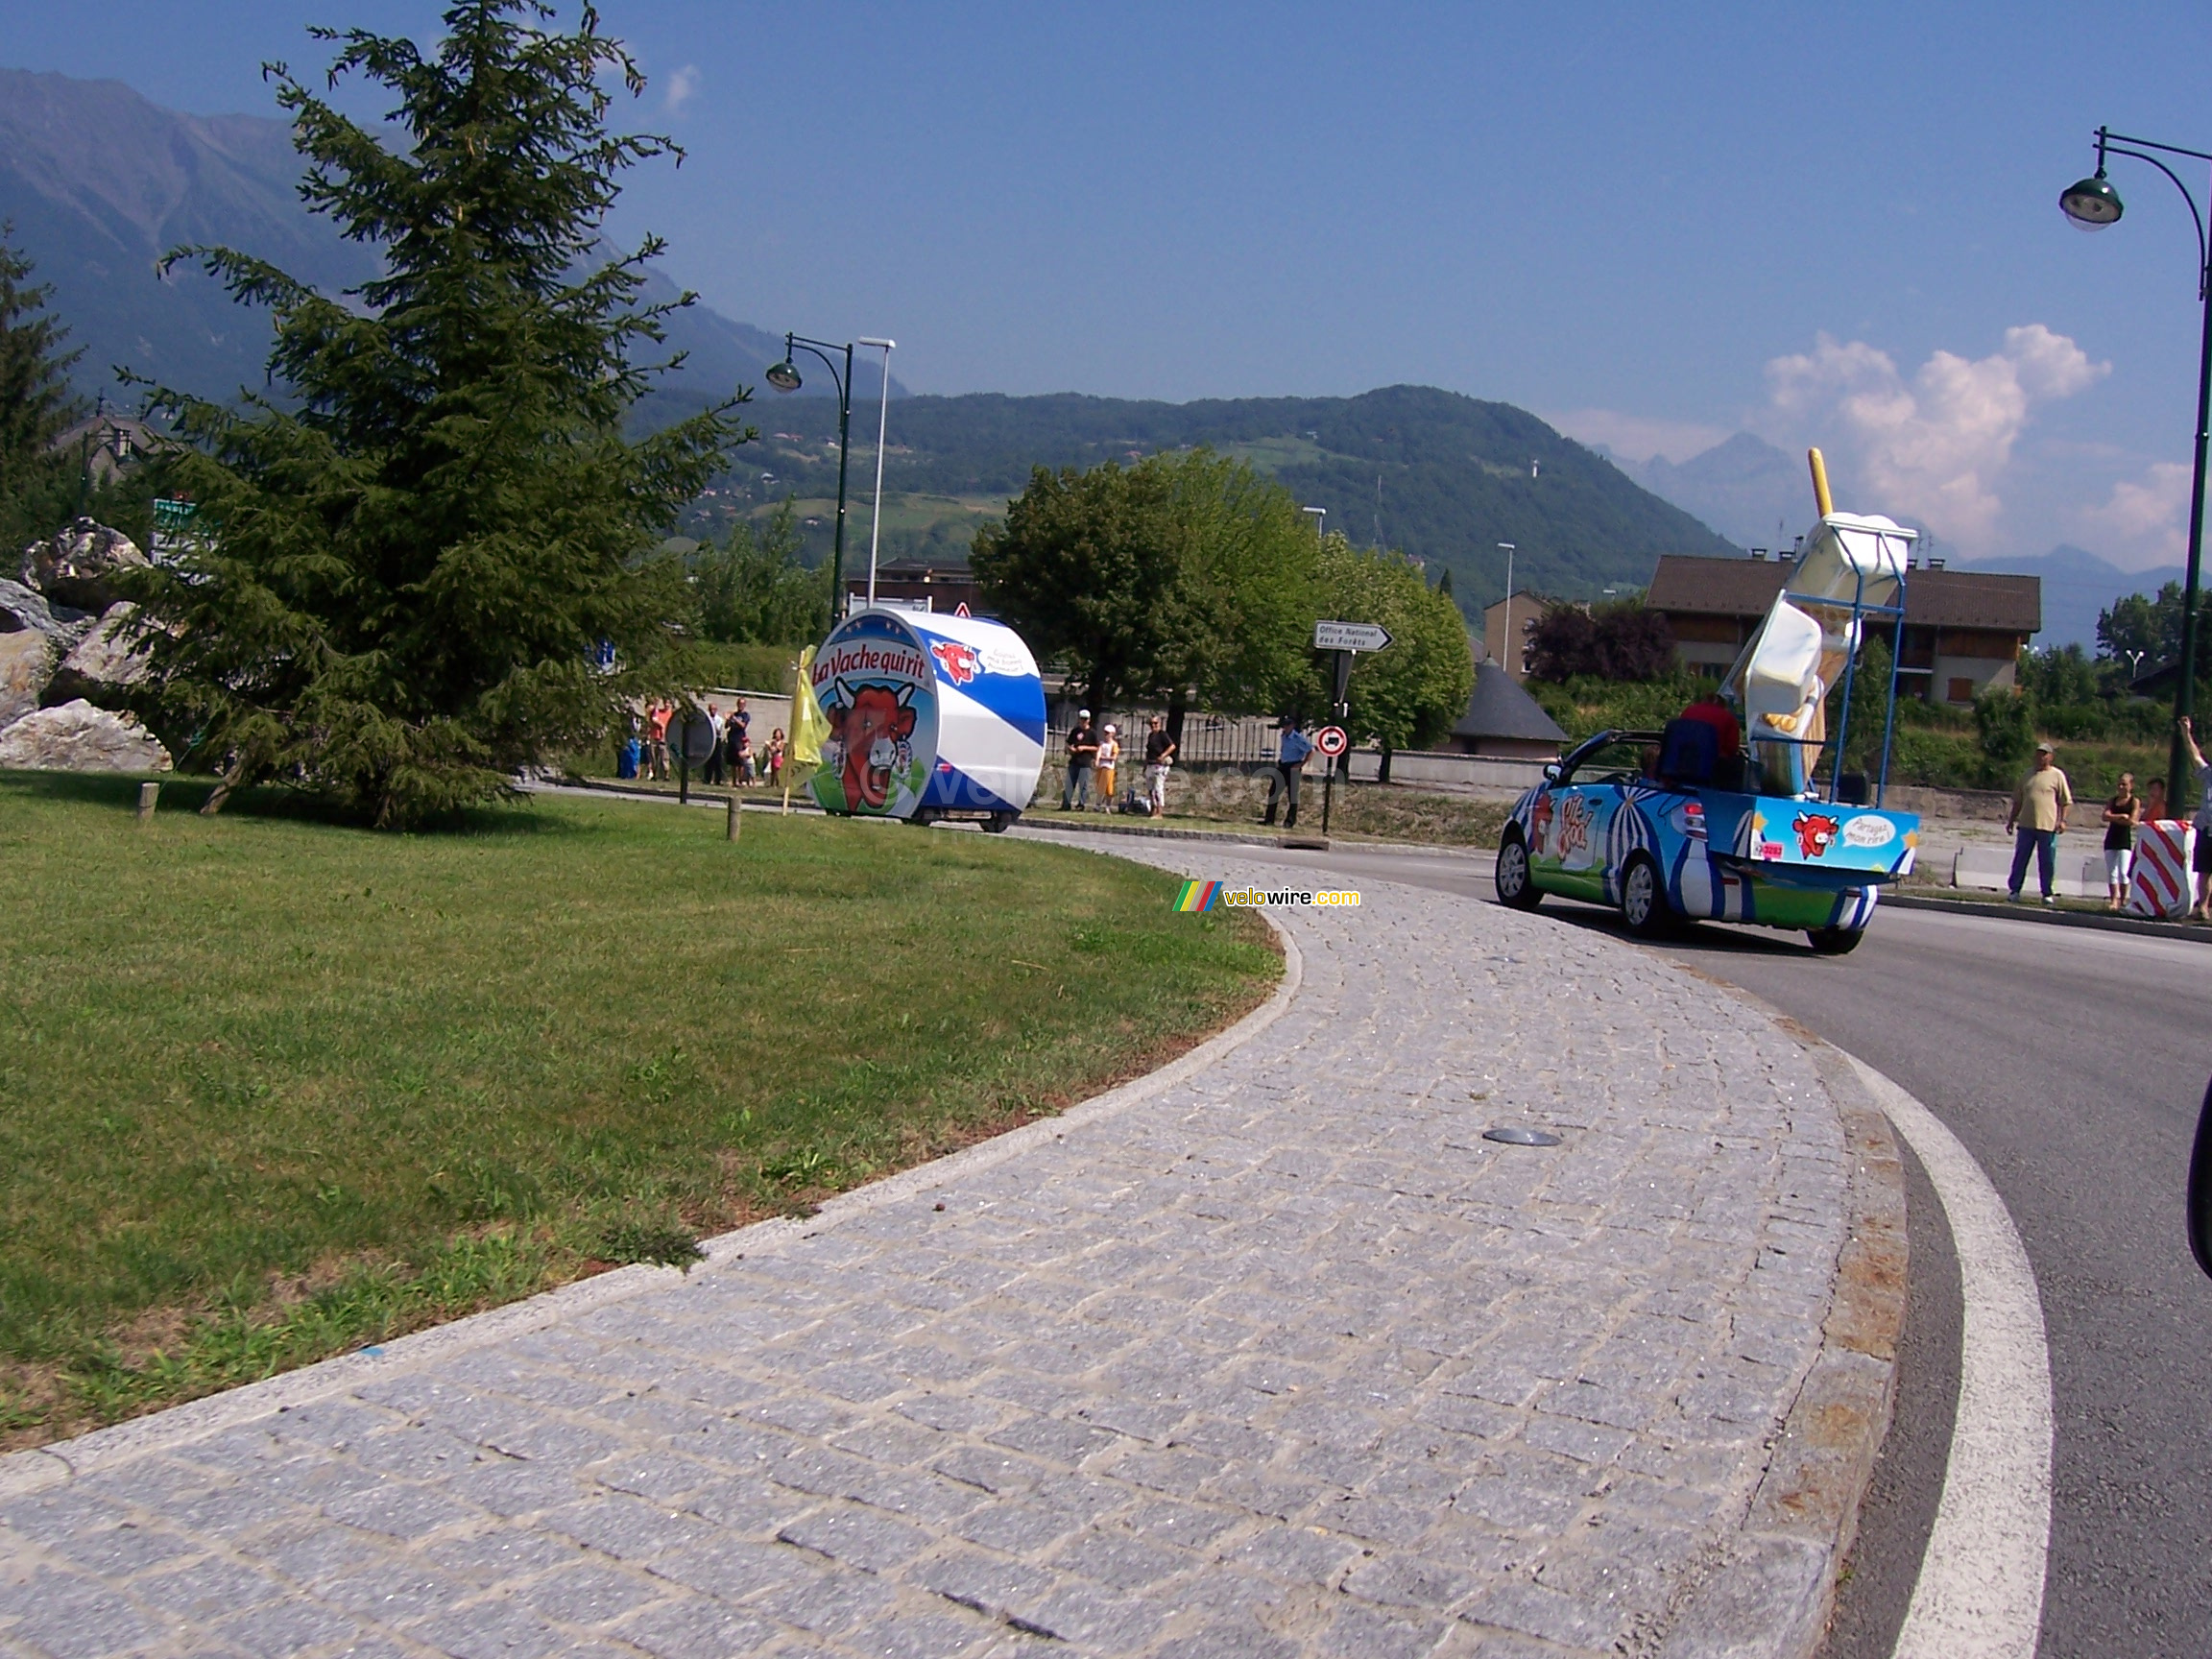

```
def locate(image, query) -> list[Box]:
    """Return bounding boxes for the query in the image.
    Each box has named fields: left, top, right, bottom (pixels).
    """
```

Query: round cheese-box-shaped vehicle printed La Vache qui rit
left=807, top=611, right=1044, bottom=830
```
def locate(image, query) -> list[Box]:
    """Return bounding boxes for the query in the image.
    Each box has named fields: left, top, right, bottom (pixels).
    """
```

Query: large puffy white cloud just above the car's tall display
left=1767, top=323, right=2112, bottom=553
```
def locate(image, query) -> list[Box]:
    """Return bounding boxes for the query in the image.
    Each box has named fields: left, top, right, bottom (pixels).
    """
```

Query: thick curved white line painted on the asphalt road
left=1851, top=1060, right=2051, bottom=1659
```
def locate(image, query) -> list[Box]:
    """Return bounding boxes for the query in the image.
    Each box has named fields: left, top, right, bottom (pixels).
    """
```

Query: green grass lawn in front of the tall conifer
left=0, top=774, right=1279, bottom=1445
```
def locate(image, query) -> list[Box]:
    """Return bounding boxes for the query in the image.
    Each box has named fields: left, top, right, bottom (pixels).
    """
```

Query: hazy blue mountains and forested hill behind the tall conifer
left=0, top=71, right=1760, bottom=611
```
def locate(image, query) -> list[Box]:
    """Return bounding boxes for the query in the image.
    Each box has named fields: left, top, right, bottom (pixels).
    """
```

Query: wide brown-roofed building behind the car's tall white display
left=1644, top=553, right=2044, bottom=706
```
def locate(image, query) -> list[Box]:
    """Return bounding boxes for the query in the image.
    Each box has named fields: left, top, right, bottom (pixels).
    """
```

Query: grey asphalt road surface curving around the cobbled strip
left=1141, top=847, right=2212, bottom=1659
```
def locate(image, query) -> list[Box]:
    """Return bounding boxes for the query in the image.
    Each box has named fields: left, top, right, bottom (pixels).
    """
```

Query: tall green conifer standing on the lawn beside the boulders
left=135, top=0, right=752, bottom=828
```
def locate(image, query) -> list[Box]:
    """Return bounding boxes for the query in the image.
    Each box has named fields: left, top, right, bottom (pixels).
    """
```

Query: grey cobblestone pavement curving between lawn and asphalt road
left=0, top=843, right=1875, bottom=1659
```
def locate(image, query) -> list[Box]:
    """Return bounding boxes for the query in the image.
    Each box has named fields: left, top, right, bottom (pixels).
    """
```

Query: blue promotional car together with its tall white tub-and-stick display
left=1496, top=449, right=1920, bottom=955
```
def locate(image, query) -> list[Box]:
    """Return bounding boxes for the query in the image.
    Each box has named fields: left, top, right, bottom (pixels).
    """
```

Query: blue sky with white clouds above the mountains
left=12, top=0, right=2212, bottom=566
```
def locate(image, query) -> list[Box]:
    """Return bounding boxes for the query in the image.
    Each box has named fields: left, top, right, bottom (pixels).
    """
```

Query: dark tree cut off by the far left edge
left=0, top=224, right=84, bottom=555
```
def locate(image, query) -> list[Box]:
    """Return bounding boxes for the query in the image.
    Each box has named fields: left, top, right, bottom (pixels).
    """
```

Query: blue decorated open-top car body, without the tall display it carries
left=1496, top=721, right=1920, bottom=955
